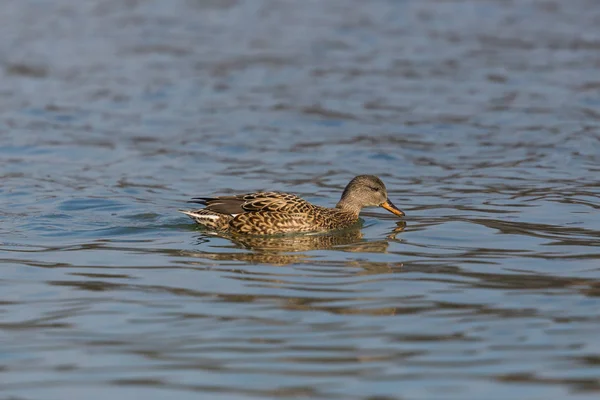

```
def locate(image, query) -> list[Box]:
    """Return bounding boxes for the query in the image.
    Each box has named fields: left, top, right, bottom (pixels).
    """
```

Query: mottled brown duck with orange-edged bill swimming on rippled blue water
left=179, top=175, right=405, bottom=235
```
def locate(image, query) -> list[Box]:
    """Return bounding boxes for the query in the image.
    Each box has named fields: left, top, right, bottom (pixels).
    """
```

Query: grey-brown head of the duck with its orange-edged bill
left=336, top=175, right=404, bottom=217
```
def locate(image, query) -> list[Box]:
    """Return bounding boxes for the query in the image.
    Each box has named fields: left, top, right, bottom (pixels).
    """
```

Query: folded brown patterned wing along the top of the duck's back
left=192, top=192, right=312, bottom=215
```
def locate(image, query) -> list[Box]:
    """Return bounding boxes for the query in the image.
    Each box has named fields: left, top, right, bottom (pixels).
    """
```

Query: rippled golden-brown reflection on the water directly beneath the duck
left=186, top=221, right=406, bottom=265
